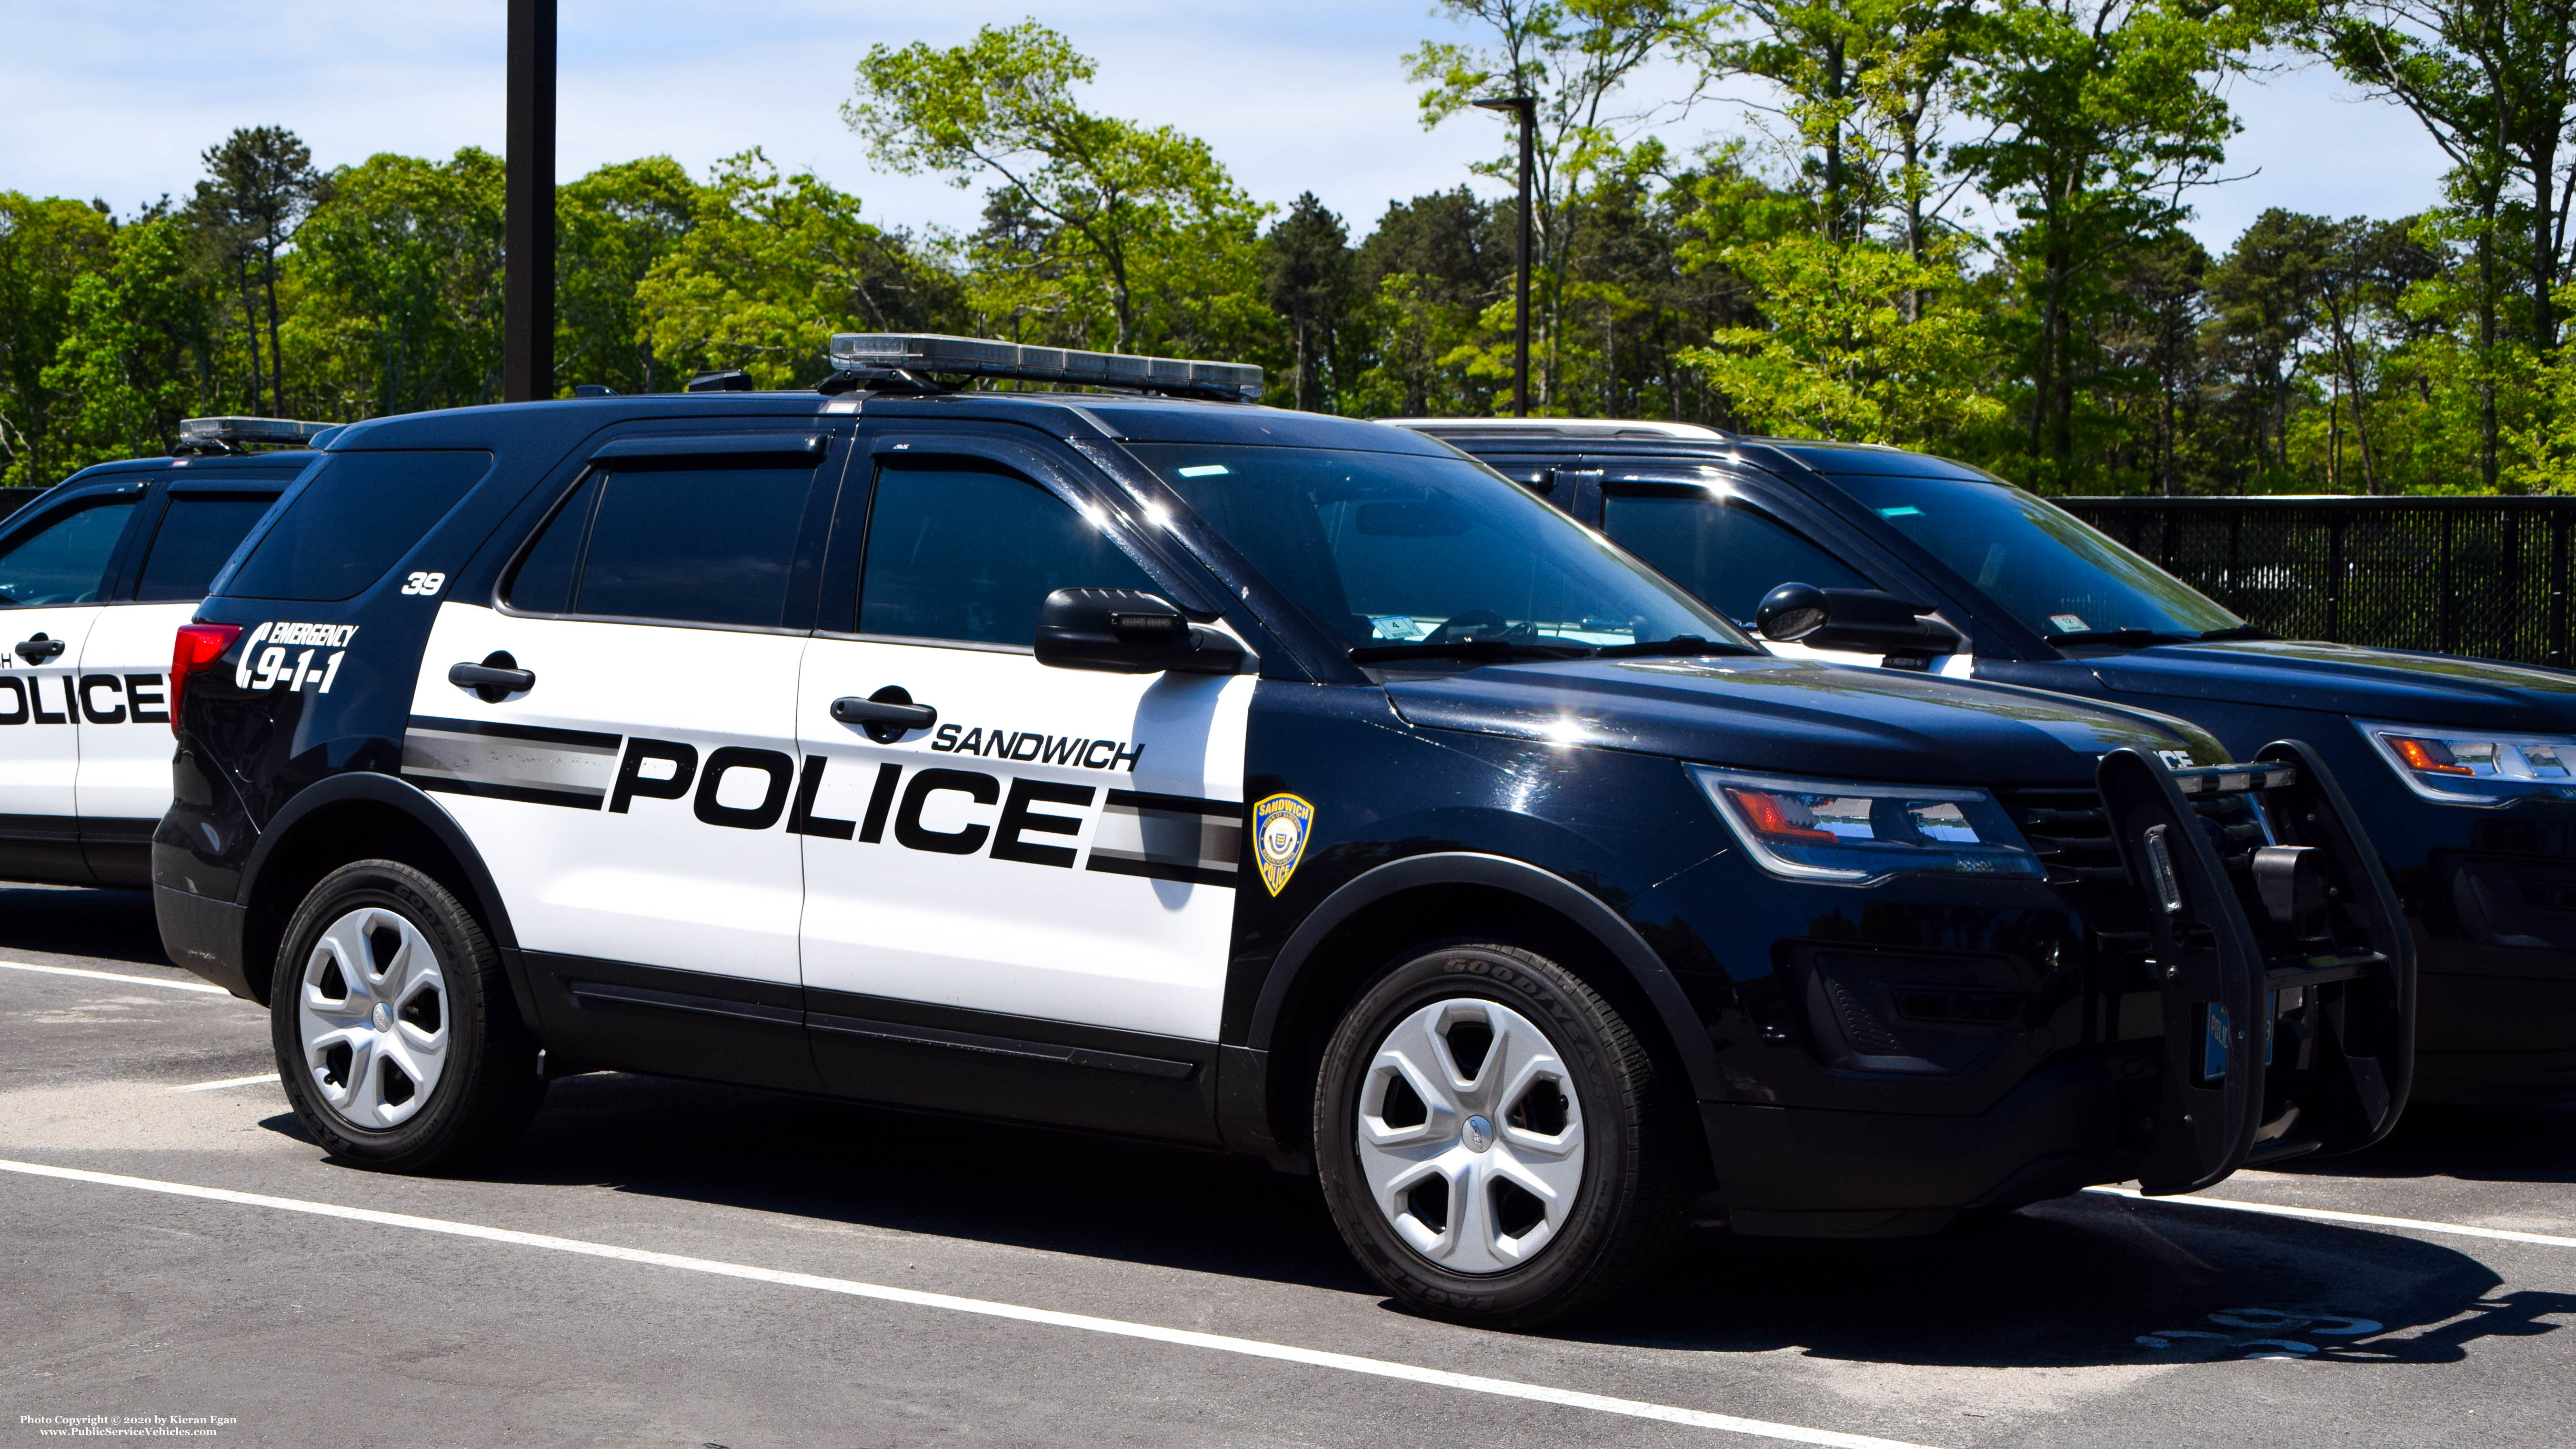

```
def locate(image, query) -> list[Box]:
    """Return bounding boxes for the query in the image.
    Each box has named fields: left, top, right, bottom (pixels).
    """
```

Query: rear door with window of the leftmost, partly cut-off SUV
left=72, top=472, right=294, bottom=887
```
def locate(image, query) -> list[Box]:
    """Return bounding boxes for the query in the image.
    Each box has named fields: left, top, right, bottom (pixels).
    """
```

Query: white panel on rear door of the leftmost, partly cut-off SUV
left=74, top=601, right=196, bottom=820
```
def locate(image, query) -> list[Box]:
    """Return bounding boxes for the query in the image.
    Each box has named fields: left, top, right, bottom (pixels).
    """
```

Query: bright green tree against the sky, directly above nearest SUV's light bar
left=842, top=20, right=1265, bottom=353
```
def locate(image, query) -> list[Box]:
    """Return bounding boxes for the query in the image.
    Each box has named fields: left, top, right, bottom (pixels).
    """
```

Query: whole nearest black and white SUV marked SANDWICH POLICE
left=152, top=335, right=2411, bottom=1325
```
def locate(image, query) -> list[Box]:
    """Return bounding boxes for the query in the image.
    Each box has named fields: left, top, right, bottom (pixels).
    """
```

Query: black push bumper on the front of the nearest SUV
left=2097, top=740, right=2414, bottom=1194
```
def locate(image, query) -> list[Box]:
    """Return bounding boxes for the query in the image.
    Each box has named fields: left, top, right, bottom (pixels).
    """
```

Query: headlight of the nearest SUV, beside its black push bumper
left=1687, top=766, right=2048, bottom=885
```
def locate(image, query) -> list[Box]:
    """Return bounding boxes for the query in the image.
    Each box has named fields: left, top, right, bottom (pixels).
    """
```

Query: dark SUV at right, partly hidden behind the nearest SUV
left=1406, top=420, right=2576, bottom=1104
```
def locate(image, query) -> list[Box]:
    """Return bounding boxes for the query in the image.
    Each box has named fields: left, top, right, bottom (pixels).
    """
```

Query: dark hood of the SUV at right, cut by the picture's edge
left=2092, top=639, right=2576, bottom=732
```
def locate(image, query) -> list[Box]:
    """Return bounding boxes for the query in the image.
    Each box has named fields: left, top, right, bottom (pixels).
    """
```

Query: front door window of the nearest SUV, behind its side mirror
left=858, top=464, right=1154, bottom=647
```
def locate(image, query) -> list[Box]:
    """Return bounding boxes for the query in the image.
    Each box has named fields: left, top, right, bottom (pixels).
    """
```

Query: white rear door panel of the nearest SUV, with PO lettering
left=402, top=604, right=806, bottom=985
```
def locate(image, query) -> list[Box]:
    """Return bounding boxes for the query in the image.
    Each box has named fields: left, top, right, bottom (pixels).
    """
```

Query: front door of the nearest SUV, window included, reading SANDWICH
left=796, top=443, right=1254, bottom=1135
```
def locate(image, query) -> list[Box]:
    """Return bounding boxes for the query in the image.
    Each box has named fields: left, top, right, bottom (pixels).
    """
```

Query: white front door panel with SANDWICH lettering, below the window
left=796, top=639, right=1260, bottom=1042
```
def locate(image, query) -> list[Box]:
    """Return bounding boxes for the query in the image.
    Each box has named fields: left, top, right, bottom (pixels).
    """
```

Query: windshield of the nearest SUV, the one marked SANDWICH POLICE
left=1128, top=443, right=1757, bottom=657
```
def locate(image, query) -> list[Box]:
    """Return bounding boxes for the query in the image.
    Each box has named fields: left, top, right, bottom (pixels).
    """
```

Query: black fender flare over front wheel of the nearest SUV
left=1244, top=851, right=1724, bottom=1101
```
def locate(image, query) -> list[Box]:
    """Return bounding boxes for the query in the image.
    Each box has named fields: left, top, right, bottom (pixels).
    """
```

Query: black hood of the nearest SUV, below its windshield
left=1386, top=655, right=2225, bottom=784
